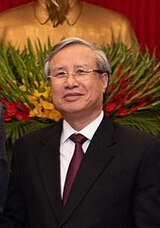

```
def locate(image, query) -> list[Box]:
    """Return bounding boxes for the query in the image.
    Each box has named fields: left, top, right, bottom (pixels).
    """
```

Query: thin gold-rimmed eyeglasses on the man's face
left=48, top=69, right=102, bottom=79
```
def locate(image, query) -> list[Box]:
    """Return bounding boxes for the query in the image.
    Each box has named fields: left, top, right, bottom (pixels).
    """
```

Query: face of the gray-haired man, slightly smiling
left=50, top=44, right=108, bottom=117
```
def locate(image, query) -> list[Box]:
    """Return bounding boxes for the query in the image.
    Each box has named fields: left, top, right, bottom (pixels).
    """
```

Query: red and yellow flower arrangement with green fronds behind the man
left=0, top=41, right=160, bottom=160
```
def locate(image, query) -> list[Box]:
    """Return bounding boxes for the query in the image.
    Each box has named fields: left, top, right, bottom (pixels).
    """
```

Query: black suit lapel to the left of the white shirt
left=37, top=124, right=61, bottom=222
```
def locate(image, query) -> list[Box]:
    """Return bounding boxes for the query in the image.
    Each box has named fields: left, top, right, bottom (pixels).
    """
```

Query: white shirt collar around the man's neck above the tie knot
left=61, top=111, right=104, bottom=144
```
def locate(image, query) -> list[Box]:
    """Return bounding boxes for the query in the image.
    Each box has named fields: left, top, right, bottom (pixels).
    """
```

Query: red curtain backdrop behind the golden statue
left=0, top=0, right=160, bottom=58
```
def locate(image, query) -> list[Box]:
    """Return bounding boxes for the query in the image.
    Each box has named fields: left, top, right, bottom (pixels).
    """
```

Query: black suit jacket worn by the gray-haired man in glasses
left=1, top=117, right=160, bottom=228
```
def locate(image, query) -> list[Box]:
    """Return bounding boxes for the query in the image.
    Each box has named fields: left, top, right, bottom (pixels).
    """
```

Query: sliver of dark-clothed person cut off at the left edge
left=0, top=103, right=9, bottom=212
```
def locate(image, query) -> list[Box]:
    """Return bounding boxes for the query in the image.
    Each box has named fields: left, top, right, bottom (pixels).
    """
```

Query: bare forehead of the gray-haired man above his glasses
left=51, top=44, right=96, bottom=64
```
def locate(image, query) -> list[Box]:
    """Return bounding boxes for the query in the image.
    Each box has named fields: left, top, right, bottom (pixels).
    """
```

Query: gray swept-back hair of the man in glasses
left=44, top=37, right=111, bottom=77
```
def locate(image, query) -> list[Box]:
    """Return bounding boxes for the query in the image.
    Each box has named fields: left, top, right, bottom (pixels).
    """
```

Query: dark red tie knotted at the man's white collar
left=63, top=134, right=87, bottom=207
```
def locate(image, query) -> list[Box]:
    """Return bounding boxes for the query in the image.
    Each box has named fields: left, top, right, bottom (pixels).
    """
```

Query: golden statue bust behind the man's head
left=0, top=0, right=136, bottom=50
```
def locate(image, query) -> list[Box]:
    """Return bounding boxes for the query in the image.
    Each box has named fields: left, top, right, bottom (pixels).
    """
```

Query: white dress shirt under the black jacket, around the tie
left=60, top=111, right=104, bottom=197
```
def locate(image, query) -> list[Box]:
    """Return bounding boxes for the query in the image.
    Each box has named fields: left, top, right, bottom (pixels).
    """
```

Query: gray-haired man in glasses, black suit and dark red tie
left=0, top=38, right=160, bottom=228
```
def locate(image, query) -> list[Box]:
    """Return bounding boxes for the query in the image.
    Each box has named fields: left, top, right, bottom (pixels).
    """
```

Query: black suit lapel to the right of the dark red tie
left=61, top=117, right=116, bottom=225
